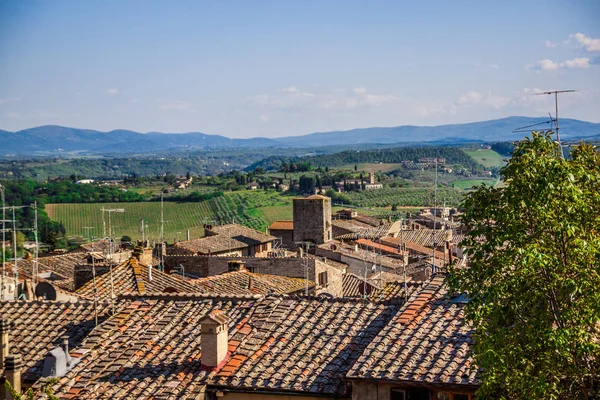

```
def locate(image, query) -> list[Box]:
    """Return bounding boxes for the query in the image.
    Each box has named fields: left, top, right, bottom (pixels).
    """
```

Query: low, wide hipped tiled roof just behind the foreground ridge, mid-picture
left=188, top=270, right=315, bottom=296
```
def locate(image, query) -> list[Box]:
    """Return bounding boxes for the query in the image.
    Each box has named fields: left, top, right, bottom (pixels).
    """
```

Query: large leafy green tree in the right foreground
left=449, top=132, right=600, bottom=399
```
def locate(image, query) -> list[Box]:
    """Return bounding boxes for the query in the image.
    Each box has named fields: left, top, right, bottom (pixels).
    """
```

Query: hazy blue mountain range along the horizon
left=0, top=117, right=600, bottom=155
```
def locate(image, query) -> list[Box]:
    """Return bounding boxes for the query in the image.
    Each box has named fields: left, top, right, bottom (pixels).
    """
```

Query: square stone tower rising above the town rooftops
left=294, top=194, right=332, bottom=244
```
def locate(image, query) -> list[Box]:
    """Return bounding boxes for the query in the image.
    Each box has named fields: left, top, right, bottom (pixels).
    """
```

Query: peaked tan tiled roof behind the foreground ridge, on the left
left=76, top=258, right=199, bottom=300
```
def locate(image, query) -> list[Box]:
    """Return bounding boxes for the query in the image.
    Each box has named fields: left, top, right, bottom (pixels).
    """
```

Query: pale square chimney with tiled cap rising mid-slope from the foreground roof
left=200, top=309, right=229, bottom=367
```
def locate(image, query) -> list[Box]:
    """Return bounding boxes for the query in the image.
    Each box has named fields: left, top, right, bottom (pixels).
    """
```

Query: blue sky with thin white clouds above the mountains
left=0, top=0, right=600, bottom=138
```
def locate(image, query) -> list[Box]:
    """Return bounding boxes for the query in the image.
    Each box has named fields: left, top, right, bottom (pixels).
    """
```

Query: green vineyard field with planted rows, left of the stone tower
left=46, top=191, right=292, bottom=242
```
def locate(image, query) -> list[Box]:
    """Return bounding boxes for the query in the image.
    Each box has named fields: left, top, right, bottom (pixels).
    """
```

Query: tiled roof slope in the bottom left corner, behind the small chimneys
left=0, top=301, right=108, bottom=381
